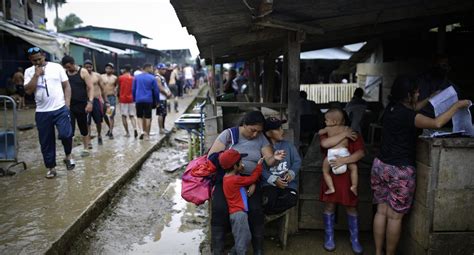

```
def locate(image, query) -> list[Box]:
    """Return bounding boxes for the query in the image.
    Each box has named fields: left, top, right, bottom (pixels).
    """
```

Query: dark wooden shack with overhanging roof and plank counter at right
left=171, top=0, right=474, bottom=254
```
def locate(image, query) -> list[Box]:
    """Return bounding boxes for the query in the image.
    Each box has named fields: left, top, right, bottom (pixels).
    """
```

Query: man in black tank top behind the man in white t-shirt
left=61, top=56, right=94, bottom=157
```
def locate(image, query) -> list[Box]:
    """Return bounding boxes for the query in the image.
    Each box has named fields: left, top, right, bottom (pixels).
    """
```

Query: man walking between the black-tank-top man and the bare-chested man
left=84, top=60, right=107, bottom=145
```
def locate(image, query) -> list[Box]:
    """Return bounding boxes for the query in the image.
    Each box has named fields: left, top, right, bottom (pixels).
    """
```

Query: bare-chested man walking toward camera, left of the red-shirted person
left=100, top=63, right=118, bottom=140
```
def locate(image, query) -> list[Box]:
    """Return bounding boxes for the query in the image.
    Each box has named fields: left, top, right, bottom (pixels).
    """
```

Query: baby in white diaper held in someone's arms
left=319, top=108, right=358, bottom=196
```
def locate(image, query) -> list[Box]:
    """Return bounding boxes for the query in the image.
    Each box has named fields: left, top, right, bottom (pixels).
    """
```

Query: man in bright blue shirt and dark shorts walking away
left=132, top=64, right=160, bottom=140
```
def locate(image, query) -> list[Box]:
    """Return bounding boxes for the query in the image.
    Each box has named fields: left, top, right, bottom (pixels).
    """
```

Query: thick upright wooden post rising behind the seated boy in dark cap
left=288, top=32, right=301, bottom=148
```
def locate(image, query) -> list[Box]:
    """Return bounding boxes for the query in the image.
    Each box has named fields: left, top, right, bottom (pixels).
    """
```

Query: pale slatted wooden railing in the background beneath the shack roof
left=300, top=83, right=358, bottom=104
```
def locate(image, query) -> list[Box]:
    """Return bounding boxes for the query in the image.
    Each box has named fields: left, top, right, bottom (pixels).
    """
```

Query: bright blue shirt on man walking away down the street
left=132, top=73, right=160, bottom=103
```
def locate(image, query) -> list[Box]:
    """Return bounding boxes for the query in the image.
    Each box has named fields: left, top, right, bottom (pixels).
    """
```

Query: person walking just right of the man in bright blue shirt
left=156, top=63, right=171, bottom=134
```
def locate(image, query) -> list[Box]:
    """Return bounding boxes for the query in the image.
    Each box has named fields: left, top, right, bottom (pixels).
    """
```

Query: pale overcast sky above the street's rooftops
left=46, top=0, right=199, bottom=57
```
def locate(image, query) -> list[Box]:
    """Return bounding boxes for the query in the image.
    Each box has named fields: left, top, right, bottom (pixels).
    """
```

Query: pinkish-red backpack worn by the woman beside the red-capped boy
left=181, top=127, right=239, bottom=205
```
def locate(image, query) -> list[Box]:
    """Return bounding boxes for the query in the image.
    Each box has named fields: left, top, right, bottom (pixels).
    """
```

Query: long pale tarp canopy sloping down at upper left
left=0, top=21, right=69, bottom=58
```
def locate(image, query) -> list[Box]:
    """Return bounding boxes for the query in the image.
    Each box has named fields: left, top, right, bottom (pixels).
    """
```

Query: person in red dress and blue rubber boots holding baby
left=319, top=107, right=365, bottom=254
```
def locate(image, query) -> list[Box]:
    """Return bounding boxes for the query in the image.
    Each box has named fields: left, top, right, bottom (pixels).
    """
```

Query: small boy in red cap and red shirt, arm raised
left=219, top=149, right=263, bottom=255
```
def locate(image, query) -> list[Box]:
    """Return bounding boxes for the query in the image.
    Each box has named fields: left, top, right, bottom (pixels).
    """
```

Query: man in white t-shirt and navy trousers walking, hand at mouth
left=24, top=47, right=75, bottom=179
